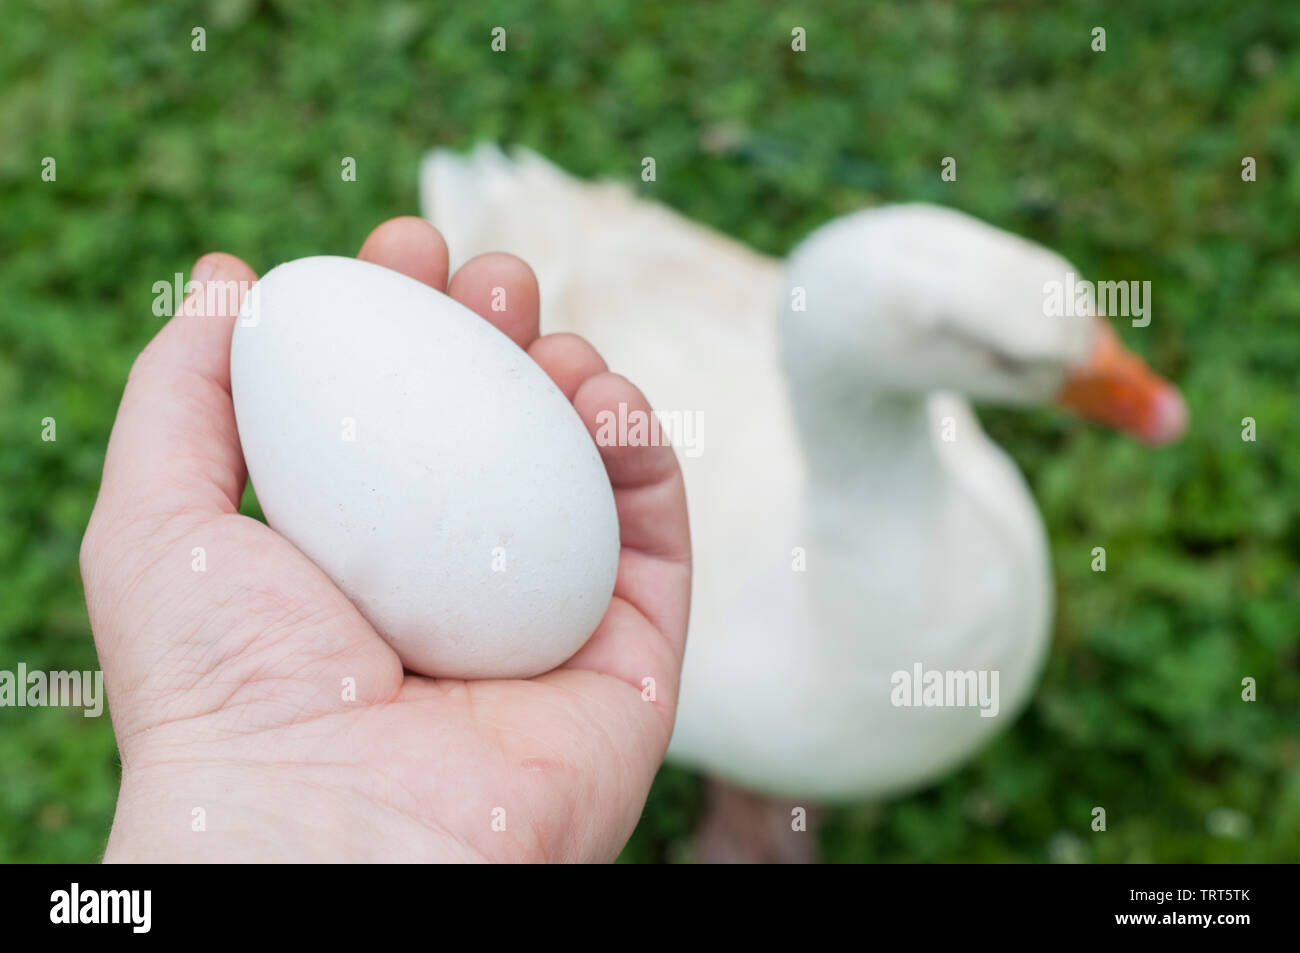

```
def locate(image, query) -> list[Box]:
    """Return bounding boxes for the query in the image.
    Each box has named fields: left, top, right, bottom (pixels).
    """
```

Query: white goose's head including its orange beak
left=781, top=204, right=1187, bottom=443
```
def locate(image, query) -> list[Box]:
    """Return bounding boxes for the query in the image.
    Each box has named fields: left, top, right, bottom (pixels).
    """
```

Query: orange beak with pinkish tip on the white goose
left=1057, top=319, right=1187, bottom=445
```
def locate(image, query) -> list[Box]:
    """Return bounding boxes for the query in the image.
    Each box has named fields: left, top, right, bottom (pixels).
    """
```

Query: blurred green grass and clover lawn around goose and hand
left=0, top=0, right=1300, bottom=862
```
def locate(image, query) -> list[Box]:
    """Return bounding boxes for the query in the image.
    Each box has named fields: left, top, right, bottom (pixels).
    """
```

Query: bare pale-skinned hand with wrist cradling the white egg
left=81, top=218, right=690, bottom=862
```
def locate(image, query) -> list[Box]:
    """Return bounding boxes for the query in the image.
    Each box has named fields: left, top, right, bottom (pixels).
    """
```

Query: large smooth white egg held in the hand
left=230, top=256, right=619, bottom=679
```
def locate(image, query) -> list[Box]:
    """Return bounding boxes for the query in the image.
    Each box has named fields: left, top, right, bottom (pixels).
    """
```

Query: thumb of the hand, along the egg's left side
left=96, top=252, right=257, bottom=517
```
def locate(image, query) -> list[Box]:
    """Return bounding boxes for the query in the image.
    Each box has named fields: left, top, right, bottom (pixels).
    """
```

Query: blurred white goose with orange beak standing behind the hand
left=420, top=146, right=1187, bottom=859
